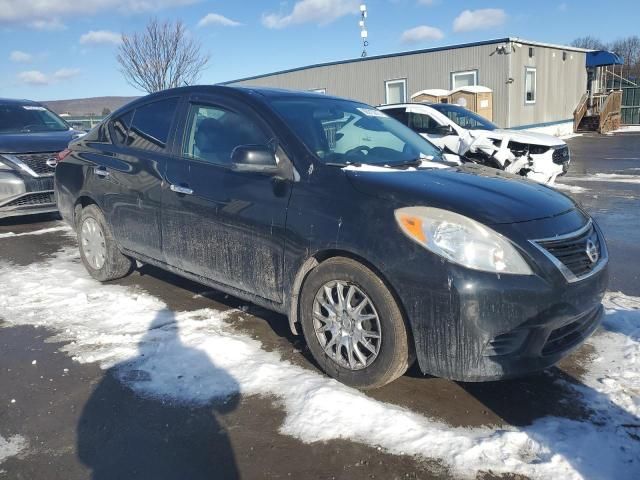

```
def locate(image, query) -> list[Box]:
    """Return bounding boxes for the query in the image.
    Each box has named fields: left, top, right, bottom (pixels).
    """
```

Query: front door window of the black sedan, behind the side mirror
left=182, top=105, right=270, bottom=165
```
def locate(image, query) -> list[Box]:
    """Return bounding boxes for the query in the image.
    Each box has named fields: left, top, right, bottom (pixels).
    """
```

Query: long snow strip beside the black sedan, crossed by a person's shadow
left=0, top=249, right=640, bottom=480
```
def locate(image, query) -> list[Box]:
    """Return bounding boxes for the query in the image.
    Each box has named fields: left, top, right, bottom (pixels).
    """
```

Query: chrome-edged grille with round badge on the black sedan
left=532, top=221, right=607, bottom=282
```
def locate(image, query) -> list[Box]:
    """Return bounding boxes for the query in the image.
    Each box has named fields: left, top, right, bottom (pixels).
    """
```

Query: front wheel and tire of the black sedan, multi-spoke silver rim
left=300, top=257, right=412, bottom=390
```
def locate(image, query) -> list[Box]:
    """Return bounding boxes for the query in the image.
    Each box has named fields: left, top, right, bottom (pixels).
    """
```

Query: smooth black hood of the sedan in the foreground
left=345, top=164, right=576, bottom=225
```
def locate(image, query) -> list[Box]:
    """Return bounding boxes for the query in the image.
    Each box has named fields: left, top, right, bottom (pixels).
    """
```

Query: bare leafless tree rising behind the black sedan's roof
left=117, top=19, right=209, bottom=93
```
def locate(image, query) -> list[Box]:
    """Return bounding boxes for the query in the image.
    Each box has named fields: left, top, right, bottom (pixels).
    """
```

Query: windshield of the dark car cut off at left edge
left=0, top=104, right=69, bottom=134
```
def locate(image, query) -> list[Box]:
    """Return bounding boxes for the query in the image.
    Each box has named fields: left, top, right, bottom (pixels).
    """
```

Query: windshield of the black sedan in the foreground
left=270, top=96, right=440, bottom=165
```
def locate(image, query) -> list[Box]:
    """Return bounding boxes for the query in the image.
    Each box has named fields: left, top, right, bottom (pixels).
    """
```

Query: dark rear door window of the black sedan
left=128, top=98, right=178, bottom=152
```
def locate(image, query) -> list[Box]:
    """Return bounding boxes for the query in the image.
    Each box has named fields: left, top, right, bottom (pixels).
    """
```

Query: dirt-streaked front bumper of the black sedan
left=386, top=216, right=608, bottom=382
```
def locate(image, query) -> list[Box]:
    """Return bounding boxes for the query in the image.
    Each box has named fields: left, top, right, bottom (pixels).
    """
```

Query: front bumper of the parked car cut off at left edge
left=0, top=171, right=57, bottom=218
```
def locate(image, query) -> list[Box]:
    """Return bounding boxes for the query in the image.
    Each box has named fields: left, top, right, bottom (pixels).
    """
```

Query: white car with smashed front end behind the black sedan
left=378, top=103, right=571, bottom=184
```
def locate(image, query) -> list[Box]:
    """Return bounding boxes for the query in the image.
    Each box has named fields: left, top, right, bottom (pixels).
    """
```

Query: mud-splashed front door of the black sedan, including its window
left=162, top=96, right=292, bottom=301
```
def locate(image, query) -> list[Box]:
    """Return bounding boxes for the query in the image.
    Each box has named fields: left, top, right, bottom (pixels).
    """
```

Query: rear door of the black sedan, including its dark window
left=102, top=97, right=179, bottom=259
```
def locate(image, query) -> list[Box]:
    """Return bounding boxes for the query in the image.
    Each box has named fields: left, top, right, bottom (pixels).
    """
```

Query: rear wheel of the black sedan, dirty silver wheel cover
left=77, top=205, right=135, bottom=282
